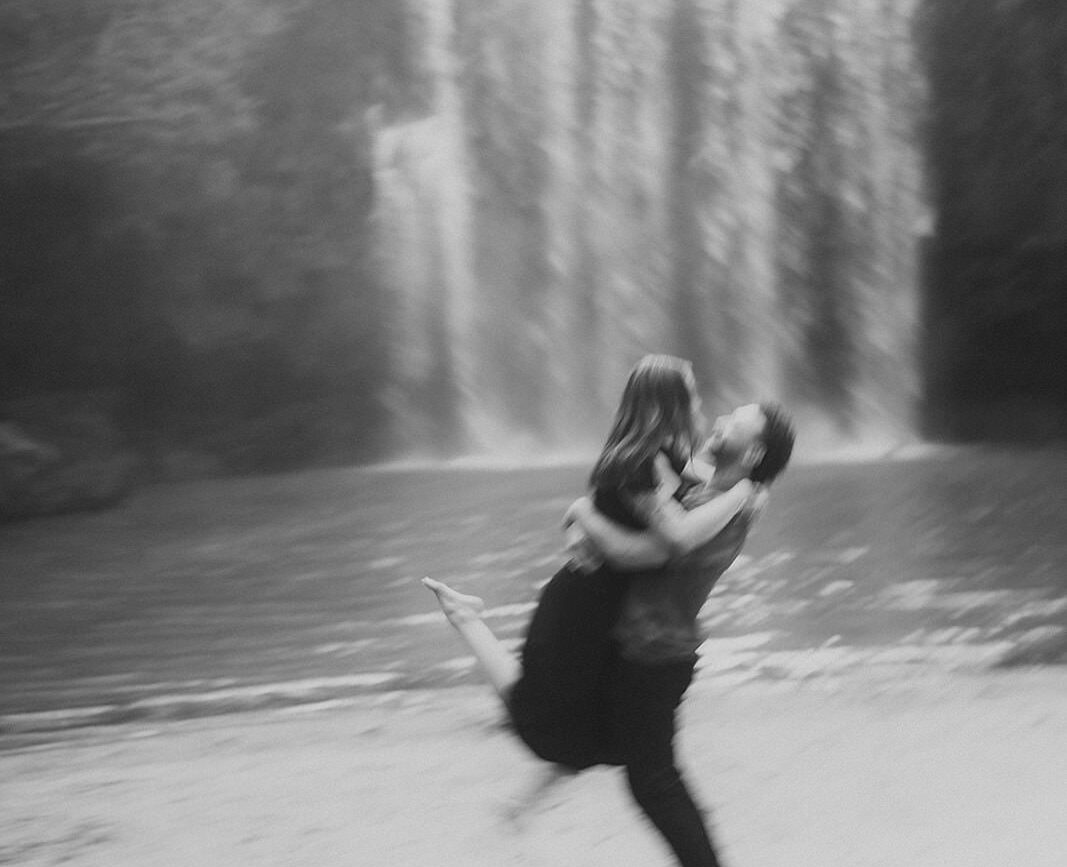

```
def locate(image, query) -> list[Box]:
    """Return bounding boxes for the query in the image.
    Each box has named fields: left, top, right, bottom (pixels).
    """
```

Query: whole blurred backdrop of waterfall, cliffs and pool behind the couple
left=0, top=0, right=1067, bottom=759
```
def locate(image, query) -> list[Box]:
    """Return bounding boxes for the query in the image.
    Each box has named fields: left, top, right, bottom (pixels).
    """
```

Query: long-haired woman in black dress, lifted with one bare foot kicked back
left=423, top=355, right=754, bottom=788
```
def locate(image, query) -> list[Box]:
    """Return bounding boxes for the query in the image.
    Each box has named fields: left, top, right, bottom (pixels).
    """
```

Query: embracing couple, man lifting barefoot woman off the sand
left=424, top=355, right=794, bottom=867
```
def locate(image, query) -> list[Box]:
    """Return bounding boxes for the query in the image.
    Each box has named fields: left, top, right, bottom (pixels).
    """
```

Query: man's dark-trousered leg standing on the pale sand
left=610, top=660, right=719, bottom=867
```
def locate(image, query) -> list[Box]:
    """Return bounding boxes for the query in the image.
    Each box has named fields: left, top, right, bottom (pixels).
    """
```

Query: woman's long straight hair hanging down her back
left=589, top=355, right=697, bottom=492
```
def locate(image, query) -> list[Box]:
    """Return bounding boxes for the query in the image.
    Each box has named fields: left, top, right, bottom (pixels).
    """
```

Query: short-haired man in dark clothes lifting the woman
left=566, top=404, right=795, bottom=867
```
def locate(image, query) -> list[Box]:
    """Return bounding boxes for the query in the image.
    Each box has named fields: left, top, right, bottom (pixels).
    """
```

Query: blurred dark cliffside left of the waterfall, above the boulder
left=0, top=0, right=407, bottom=468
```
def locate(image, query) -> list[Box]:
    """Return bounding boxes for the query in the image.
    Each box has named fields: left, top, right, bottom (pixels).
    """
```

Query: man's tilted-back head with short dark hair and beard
left=707, top=403, right=796, bottom=484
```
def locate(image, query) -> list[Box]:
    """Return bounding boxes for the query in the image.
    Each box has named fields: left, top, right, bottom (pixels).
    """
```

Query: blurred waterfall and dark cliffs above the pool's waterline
left=0, top=0, right=1067, bottom=518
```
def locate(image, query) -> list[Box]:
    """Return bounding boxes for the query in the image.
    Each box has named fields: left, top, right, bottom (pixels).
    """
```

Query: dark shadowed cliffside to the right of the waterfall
left=917, top=0, right=1067, bottom=440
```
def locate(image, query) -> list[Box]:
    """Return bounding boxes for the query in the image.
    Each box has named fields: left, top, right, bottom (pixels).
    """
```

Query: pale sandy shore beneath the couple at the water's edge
left=0, top=669, right=1067, bottom=867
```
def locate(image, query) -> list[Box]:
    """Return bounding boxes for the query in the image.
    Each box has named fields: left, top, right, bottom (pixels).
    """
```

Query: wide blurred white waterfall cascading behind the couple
left=372, top=0, right=927, bottom=453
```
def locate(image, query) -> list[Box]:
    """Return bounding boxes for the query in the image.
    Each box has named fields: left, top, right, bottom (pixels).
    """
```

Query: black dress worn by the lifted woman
left=508, top=492, right=644, bottom=770
